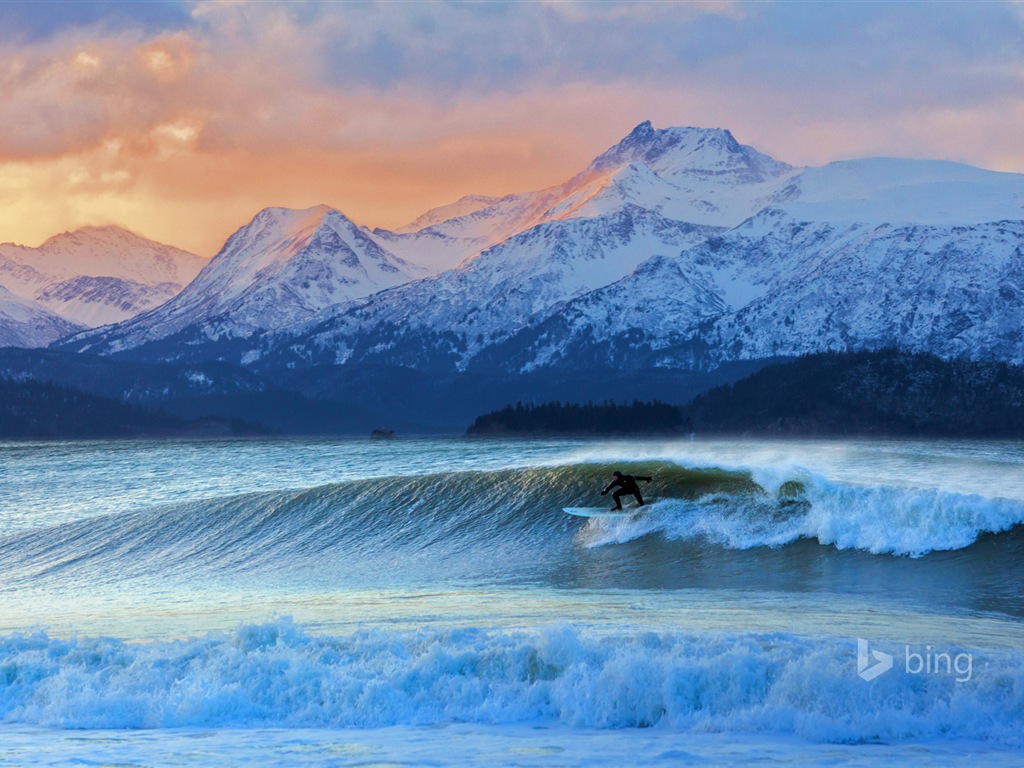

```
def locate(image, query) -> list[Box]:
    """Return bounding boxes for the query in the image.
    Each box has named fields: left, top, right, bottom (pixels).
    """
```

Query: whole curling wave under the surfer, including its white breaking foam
left=0, top=462, right=1024, bottom=579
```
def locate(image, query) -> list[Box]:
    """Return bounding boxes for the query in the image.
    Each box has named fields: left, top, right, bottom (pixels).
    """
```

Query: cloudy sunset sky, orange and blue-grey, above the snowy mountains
left=0, top=0, right=1024, bottom=256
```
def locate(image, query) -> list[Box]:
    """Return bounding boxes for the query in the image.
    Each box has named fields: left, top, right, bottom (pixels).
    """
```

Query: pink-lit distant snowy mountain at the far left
left=0, top=226, right=206, bottom=327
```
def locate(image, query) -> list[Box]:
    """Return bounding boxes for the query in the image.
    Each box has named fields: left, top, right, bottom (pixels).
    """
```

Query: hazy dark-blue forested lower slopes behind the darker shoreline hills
left=0, top=348, right=756, bottom=435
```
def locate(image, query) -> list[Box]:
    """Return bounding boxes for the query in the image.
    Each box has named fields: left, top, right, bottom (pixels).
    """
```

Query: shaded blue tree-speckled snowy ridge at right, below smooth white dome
left=501, top=208, right=1024, bottom=371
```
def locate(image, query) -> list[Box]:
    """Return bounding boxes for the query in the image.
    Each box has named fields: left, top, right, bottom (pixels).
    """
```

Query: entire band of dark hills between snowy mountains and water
left=8, top=349, right=1024, bottom=438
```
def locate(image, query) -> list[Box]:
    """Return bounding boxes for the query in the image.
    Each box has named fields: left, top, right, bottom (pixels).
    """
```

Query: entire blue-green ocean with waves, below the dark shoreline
left=0, top=437, right=1024, bottom=766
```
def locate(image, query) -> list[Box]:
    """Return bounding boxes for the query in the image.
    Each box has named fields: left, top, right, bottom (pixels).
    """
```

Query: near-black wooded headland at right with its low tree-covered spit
left=469, top=349, right=1024, bottom=438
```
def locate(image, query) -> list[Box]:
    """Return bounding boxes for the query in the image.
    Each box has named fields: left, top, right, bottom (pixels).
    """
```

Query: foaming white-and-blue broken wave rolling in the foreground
left=0, top=618, right=1024, bottom=746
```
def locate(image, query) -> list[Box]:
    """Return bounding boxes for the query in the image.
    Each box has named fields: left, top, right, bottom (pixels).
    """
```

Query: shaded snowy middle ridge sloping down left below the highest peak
left=260, top=206, right=716, bottom=369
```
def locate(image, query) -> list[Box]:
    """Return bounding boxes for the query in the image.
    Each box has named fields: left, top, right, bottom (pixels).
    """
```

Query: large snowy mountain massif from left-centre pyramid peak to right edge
left=49, top=123, right=1024, bottom=374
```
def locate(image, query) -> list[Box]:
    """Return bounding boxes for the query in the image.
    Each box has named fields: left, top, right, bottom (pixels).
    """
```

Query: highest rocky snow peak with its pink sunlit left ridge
left=377, top=122, right=797, bottom=268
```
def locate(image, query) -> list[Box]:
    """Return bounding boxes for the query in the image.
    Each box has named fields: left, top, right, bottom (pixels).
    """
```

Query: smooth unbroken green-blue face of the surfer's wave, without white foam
left=0, top=465, right=757, bottom=579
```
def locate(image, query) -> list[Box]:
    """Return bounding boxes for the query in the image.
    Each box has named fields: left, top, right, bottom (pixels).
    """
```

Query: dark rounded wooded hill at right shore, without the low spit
left=683, top=350, right=1024, bottom=437
